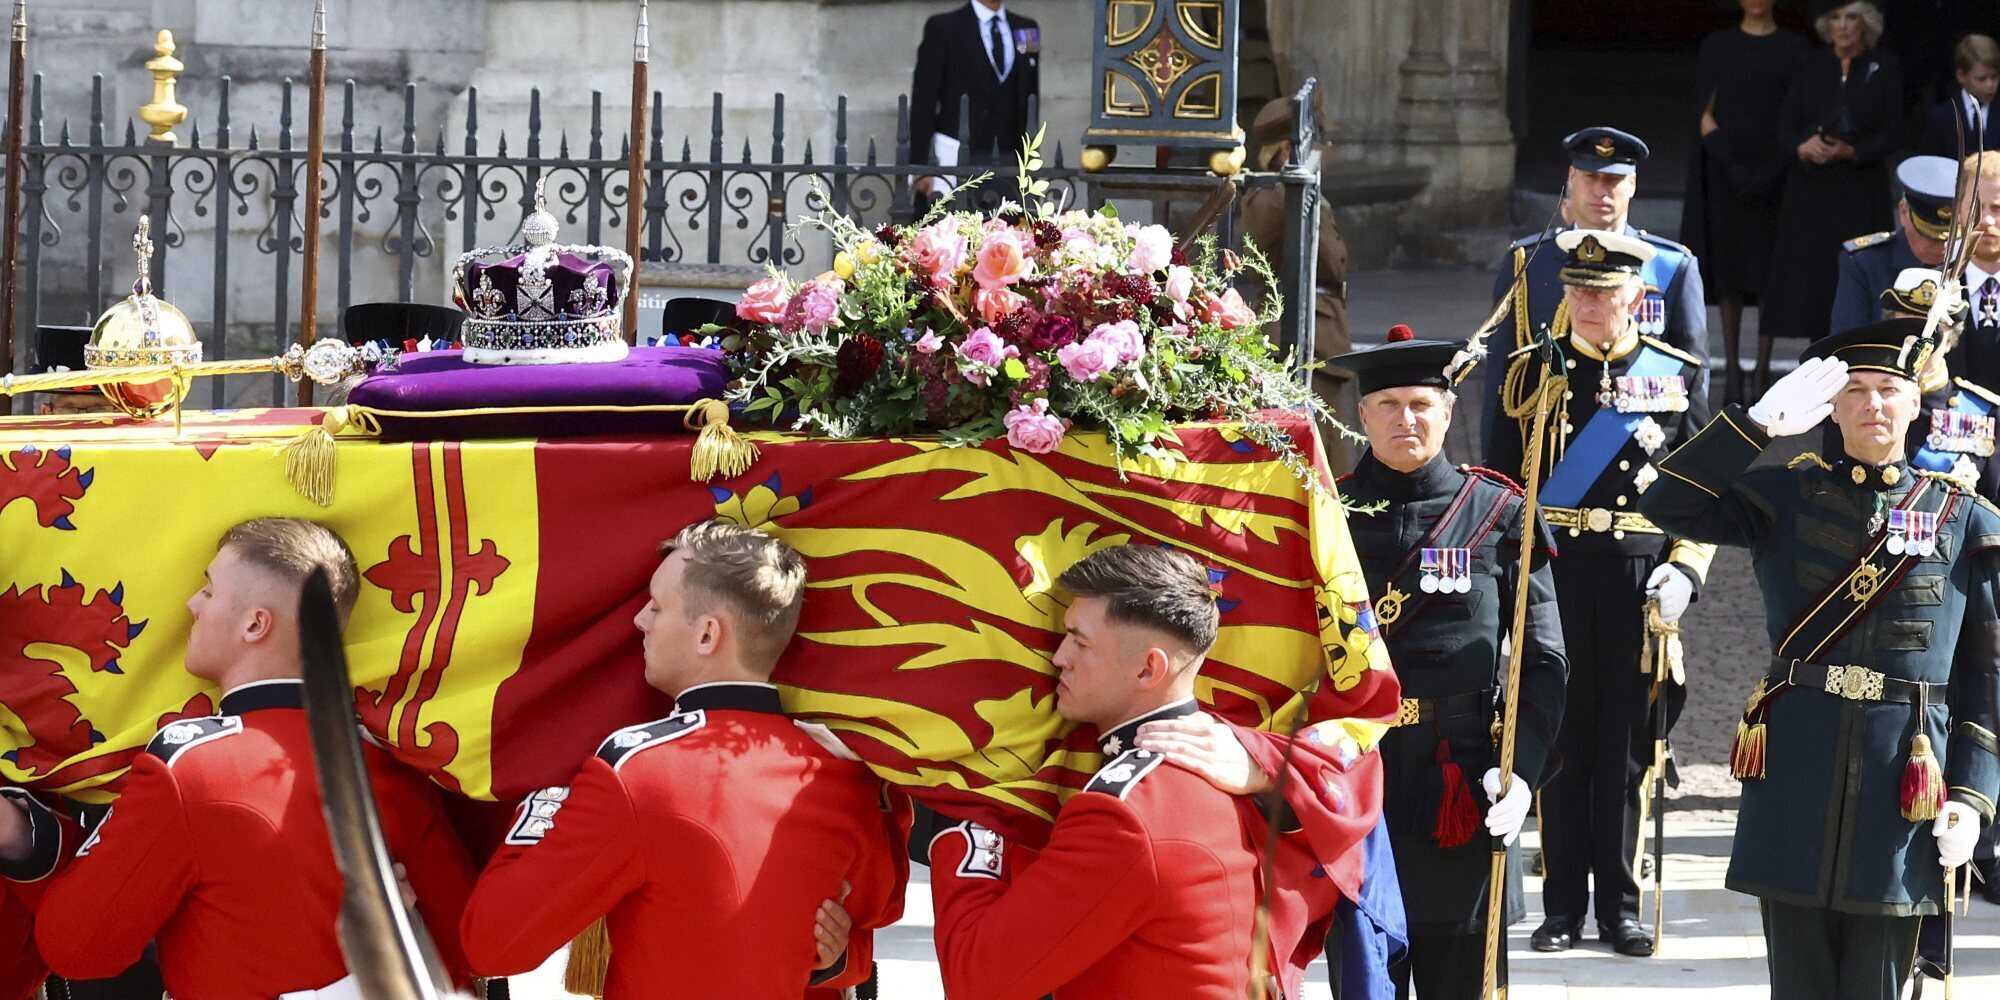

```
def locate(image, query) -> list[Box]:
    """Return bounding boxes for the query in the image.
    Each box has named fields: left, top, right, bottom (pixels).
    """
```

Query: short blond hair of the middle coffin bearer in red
left=660, top=520, right=806, bottom=666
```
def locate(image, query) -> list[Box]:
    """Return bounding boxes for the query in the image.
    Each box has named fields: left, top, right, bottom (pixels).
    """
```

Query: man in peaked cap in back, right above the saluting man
left=1832, top=156, right=1958, bottom=334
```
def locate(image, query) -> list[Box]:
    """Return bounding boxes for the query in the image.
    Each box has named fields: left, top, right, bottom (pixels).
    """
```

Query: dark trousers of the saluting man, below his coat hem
left=1758, top=900, right=1924, bottom=1000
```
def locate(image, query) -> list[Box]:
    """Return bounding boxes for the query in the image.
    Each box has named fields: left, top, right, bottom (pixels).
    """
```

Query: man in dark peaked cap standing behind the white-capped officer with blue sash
left=1480, top=126, right=1734, bottom=430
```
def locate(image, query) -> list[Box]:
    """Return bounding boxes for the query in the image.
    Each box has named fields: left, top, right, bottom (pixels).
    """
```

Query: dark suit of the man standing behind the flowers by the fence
left=910, top=2, right=1042, bottom=164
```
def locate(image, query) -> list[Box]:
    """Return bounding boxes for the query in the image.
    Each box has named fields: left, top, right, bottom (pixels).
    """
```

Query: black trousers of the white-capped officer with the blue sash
left=1542, top=552, right=1658, bottom=926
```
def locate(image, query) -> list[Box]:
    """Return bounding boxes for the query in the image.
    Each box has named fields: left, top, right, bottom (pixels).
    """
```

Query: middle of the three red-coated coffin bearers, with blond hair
left=460, top=520, right=910, bottom=1000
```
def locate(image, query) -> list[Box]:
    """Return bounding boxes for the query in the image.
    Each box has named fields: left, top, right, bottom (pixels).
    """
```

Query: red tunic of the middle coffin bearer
left=462, top=684, right=910, bottom=1000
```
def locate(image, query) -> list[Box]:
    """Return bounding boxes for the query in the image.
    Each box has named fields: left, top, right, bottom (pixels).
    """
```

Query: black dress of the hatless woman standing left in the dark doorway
left=1680, top=28, right=1810, bottom=304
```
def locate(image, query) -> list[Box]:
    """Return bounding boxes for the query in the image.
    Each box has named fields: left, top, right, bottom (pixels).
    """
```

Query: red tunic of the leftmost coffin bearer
left=36, top=680, right=474, bottom=1000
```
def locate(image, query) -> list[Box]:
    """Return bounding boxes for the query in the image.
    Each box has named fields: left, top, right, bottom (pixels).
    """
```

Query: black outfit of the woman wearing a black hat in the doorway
left=1758, top=48, right=1902, bottom=340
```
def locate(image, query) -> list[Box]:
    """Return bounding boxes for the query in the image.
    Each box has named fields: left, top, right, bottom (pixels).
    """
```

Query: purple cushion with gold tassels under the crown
left=348, top=348, right=728, bottom=440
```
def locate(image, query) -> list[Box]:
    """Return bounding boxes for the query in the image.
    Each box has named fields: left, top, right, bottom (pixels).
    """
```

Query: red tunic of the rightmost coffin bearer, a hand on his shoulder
left=930, top=700, right=1264, bottom=1000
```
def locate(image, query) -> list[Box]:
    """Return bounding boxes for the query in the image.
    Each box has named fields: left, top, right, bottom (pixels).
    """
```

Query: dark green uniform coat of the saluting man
left=1640, top=406, right=2000, bottom=916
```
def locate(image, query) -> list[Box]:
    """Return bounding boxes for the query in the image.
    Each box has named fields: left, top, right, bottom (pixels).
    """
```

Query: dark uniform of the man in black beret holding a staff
left=1340, top=452, right=1568, bottom=1000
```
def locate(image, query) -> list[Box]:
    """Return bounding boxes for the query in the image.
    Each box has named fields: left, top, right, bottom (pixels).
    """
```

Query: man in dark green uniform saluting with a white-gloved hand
left=1642, top=318, right=2000, bottom=1000
